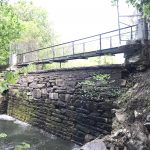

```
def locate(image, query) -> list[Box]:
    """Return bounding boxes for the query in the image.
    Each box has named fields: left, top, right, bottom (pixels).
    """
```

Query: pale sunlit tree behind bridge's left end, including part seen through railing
left=11, top=0, right=57, bottom=61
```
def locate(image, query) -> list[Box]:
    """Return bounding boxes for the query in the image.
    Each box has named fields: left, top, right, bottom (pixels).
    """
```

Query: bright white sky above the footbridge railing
left=34, top=0, right=135, bottom=42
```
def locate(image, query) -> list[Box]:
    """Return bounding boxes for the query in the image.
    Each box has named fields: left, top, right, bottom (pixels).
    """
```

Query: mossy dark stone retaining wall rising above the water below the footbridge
left=8, top=65, right=122, bottom=143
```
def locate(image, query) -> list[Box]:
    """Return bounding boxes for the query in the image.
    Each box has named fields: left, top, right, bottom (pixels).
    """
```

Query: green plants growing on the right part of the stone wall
left=78, top=74, right=120, bottom=100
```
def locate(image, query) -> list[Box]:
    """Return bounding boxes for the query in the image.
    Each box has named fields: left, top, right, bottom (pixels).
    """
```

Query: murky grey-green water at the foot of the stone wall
left=0, top=115, right=77, bottom=150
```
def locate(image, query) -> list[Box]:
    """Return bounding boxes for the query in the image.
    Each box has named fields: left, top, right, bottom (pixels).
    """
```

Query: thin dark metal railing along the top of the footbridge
left=17, top=25, right=137, bottom=64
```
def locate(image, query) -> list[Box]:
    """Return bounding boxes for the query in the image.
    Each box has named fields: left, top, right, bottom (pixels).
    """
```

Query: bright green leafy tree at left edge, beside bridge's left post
left=0, top=0, right=21, bottom=65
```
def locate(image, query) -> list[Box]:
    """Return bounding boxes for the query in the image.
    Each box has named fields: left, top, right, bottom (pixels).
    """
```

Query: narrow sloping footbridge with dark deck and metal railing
left=17, top=25, right=139, bottom=67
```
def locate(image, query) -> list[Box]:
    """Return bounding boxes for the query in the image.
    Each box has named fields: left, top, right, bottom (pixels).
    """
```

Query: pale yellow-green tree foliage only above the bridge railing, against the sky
left=13, top=0, right=54, bottom=51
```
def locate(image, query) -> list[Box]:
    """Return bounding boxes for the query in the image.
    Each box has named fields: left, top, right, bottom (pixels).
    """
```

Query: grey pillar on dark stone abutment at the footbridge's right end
left=125, top=18, right=150, bottom=67
